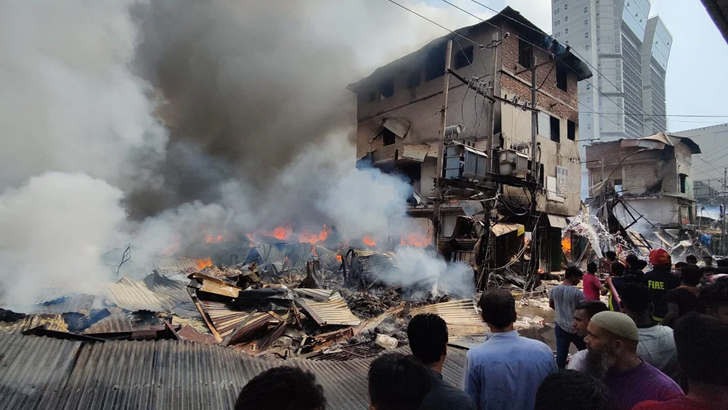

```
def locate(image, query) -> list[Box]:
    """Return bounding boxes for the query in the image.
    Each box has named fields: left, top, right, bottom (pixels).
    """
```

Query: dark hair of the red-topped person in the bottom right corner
left=674, top=313, right=728, bottom=387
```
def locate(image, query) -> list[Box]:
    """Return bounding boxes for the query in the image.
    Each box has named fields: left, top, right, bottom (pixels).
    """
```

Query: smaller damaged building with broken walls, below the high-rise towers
left=586, top=132, right=700, bottom=229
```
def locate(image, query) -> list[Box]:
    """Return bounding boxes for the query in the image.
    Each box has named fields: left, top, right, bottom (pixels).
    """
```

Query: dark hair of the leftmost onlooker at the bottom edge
left=235, top=366, right=326, bottom=410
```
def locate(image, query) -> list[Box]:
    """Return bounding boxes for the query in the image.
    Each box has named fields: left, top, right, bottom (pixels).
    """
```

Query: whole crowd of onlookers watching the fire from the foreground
left=230, top=250, right=728, bottom=410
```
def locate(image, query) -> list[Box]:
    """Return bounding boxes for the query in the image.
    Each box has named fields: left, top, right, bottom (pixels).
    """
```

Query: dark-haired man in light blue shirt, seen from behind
left=464, top=289, right=557, bottom=410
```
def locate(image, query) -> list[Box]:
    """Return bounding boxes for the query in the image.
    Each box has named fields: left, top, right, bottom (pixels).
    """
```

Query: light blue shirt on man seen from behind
left=463, top=330, right=558, bottom=410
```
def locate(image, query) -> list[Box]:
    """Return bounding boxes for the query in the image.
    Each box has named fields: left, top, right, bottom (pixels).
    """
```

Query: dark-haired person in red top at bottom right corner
left=634, top=313, right=728, bottom=410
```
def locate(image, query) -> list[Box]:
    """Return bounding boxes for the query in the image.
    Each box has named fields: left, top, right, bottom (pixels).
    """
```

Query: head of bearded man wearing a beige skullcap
left=584, top=312, right=640, bottom=379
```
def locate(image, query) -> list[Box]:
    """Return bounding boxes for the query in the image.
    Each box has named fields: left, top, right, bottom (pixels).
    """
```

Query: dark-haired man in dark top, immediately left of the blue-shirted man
left=407, top=313, right=475, bottom=410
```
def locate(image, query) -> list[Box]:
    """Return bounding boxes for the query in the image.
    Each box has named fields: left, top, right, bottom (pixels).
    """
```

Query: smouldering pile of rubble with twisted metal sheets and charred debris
left=0, top=244, right=486, bottom=360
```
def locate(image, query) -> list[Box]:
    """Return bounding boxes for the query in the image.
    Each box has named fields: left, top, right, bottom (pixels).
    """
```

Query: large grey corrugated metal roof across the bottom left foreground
left=0, top=334, right=465, bottom=410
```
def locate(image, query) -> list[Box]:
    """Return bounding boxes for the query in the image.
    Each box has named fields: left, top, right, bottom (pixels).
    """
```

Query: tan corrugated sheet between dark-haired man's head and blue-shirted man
left=412, top=299, right=486, bottom=336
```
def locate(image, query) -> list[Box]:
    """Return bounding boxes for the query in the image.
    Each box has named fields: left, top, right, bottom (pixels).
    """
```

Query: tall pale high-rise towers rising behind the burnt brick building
left=551, top=0, right=672, bottom=196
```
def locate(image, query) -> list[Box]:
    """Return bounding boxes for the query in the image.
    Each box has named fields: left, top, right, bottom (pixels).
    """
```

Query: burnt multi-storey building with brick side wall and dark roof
left=347, top=7, right=592, bottom=237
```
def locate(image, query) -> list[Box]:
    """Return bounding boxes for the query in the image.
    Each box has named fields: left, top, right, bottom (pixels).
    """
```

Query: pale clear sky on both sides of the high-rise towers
left=396, top=0, right=728, bottom=131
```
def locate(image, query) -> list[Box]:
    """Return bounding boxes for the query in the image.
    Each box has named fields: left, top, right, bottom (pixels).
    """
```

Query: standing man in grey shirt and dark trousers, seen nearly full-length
left=549, top=266, right=586, bottom=369
